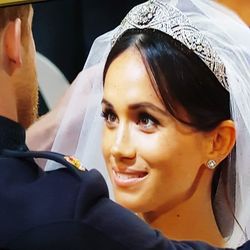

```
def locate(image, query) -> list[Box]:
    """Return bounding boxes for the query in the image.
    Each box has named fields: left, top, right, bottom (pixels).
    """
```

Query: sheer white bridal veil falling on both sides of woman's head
left=45, top=0, right=250, bottom=247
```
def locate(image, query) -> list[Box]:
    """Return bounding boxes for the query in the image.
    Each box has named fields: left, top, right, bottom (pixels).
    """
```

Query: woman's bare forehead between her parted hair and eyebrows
left=104, top=49, right=164, bottom=108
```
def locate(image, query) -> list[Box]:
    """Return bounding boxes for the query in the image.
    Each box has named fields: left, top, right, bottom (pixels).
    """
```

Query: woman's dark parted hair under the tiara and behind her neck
left=103, top=29, right=235, bottom=236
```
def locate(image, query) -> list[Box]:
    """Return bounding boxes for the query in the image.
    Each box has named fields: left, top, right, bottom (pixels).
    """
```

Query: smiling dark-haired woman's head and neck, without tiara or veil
left=100, top=29, right=235, bottom=246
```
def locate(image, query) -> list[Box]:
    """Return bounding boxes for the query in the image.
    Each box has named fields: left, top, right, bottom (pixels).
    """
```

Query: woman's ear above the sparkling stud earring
left=207, top=120, right=236, bottom=164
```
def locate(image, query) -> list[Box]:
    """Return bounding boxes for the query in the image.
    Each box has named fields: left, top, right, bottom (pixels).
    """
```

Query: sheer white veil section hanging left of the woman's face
left=45, top=30, right=115, bottom=195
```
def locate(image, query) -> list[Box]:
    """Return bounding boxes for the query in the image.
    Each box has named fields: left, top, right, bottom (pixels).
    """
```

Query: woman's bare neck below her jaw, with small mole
left=141, top=175, right=225, bottom=247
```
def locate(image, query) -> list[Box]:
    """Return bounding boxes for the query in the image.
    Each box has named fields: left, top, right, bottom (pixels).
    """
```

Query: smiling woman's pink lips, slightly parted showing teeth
left=112, top=169, right=148, bottom=187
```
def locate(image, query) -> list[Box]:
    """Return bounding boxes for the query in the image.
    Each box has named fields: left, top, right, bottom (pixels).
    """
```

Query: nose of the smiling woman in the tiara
left=111, top=122, right=136, bottom=159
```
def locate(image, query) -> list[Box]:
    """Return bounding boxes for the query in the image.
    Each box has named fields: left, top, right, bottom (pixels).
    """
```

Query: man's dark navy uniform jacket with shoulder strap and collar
left=0, top=117, right=250, bottom=250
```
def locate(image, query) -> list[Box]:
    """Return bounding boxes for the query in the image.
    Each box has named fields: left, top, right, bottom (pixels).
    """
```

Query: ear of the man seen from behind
left=3, top=18, right=22, bottom=75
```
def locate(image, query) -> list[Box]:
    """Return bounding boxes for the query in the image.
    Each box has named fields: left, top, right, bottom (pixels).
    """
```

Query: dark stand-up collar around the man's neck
left=0, top=116, right=26, bottom=150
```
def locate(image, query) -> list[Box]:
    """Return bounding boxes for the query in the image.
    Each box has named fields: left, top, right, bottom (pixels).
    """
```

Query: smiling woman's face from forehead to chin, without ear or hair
left=102, top=48, right=209, bottom=213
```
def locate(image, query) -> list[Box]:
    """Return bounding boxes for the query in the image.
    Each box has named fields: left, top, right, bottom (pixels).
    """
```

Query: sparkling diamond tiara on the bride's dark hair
left=112, top=0, right=229, bottom=90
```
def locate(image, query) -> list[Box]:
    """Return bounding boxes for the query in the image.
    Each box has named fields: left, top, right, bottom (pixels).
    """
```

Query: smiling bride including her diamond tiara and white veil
left=26, top=0, right=250, bottom=246
